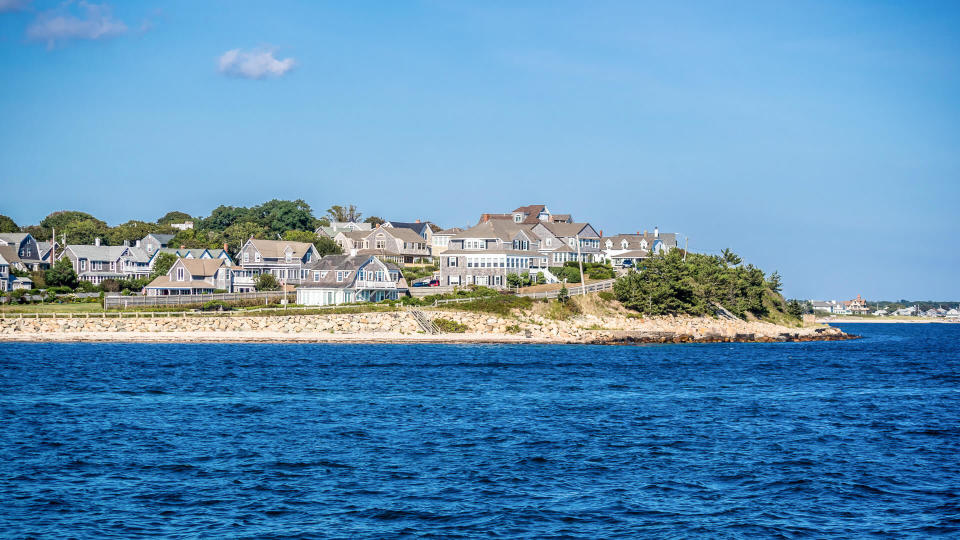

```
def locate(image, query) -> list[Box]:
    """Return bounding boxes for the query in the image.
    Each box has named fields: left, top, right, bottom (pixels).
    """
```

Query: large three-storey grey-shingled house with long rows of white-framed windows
left=439, top=219, right=556, bottom=288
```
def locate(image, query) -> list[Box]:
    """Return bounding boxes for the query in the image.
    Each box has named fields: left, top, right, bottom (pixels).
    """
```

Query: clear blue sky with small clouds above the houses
left=0, top=0, right=960, bottom=299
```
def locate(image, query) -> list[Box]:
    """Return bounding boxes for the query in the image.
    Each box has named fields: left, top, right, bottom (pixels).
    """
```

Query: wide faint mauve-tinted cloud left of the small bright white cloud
left=27, top=0, right=127, bottom=48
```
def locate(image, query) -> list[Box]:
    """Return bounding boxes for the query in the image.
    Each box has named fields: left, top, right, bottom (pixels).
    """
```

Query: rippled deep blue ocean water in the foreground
left=0, top=324, right=960, bottom=538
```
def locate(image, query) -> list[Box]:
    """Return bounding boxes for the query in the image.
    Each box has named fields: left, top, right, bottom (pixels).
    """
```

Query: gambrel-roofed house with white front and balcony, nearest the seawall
left=297, top=255, right=407, bottom=306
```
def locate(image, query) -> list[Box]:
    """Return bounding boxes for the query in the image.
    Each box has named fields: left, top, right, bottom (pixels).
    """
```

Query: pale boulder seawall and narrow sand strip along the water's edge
left=0, top=310, right=850, bottom=343
